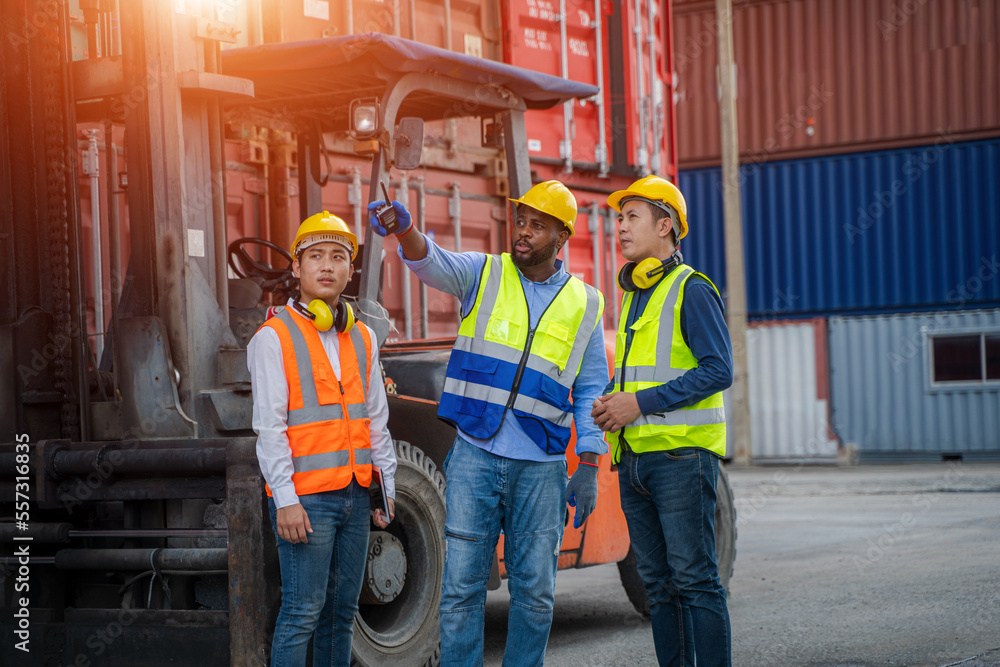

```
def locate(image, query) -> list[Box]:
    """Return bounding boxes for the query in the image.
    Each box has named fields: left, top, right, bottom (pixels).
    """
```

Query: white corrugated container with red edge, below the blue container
left=726, top=319, right=837, bottom=462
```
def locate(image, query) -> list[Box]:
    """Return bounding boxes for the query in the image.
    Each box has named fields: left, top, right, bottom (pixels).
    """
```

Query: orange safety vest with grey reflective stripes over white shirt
left=262, top=308, right=372, bottom=496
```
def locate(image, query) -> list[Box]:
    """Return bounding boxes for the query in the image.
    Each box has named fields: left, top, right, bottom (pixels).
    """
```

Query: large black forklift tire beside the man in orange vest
left=351, top=440, right=445, bottom=667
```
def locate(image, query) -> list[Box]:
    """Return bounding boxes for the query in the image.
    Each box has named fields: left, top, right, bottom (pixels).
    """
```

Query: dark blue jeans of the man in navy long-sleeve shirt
left=618, top=448, right=732, bottom=667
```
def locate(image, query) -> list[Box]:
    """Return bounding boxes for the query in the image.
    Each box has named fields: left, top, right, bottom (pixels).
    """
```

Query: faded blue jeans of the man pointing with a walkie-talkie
left=441, top=438, right=566, bottom=667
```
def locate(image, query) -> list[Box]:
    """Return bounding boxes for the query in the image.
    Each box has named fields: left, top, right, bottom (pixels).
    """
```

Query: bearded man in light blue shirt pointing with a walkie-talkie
left=369, top=181, right=608, bottom=667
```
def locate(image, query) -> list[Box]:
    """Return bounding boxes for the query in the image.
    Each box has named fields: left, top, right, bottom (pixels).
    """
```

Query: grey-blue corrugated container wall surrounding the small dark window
left=829, top=310, right=1000, bottom=461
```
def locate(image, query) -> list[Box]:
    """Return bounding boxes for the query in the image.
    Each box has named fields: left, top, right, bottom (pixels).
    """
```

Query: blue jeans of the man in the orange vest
left=267, top=480, right=370, bottom=667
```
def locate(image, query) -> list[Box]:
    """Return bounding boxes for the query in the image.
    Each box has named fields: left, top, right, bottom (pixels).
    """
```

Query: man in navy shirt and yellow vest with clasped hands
left=593, top=176, right=733, bottom=667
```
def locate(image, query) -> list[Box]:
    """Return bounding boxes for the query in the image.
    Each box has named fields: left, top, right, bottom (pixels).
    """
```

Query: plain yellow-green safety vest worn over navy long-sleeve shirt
left=607, top=264, right=726, bottom=463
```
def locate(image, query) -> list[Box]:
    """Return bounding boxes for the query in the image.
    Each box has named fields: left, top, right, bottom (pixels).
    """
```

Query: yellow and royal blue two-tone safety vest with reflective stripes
left=438, top=253, right=604, bottom=454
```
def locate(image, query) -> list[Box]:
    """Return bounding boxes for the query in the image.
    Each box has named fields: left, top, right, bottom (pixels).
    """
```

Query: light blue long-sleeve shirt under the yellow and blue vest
left=396, top=236, right=608, bottom=461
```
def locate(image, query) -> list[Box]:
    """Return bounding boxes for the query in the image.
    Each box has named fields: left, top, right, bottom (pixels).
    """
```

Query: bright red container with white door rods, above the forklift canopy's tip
left=504, top=0, right=675, bottom=176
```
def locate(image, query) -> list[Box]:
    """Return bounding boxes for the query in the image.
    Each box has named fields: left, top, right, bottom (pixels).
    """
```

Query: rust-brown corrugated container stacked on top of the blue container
left=674, top=0, right=1000, bottom=169
